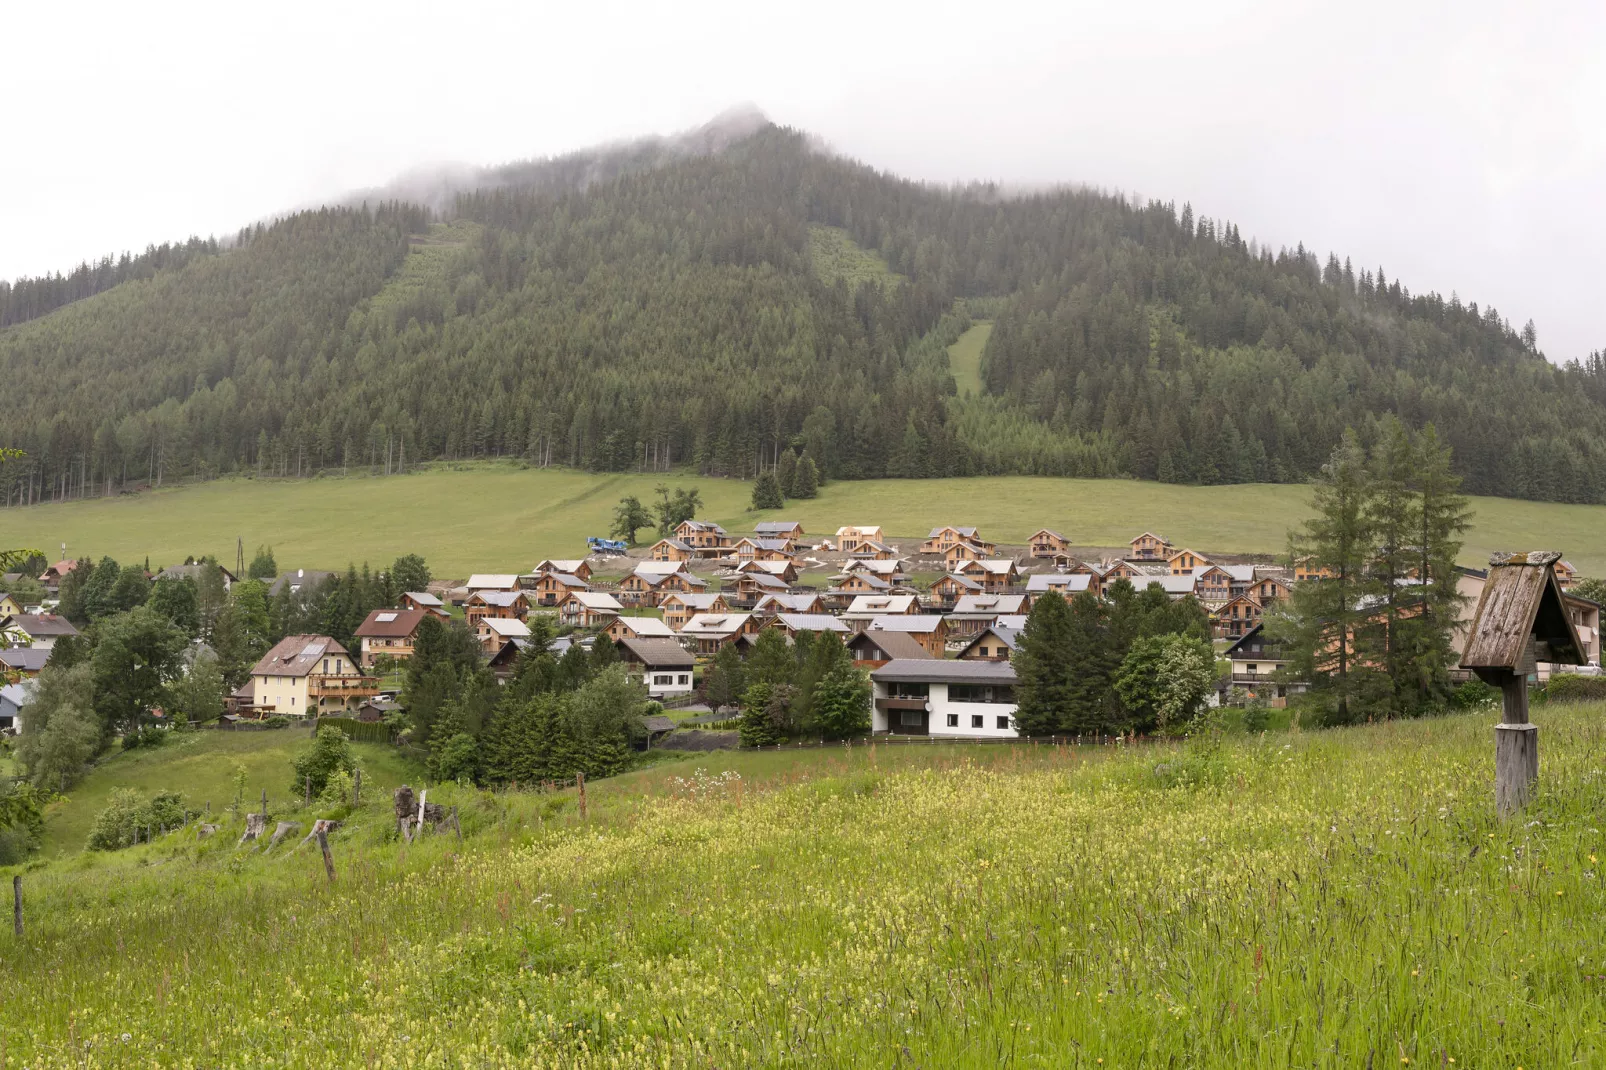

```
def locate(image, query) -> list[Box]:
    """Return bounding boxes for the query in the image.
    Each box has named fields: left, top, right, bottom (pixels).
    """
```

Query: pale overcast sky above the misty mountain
left=0, top=0, right=1606, bottom=360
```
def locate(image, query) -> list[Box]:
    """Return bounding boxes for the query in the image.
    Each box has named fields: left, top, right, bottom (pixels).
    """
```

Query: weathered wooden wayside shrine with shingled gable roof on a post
left=1461, top=549, right=1587, bottom=816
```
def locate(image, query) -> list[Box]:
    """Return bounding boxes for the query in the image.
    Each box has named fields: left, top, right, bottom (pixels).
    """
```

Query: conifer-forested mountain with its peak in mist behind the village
left=0, top=118, right=1606, bottom=503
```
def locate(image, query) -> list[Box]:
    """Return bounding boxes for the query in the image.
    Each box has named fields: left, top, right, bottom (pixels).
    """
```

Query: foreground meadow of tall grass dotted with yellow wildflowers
left=0, top=705, right=1606, bottom=1070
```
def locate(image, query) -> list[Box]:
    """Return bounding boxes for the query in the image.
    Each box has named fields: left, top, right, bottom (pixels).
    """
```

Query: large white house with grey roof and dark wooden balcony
left=870, top=659, right=1020, bottom=739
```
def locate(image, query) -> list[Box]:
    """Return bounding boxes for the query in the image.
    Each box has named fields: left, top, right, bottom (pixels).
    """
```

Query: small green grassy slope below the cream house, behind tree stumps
left=45, top=729, right=421, bottom=856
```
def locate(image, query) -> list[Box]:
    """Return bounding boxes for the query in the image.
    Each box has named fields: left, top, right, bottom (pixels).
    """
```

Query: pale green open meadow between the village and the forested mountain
left=0, top=464, right=1606, bottom=577
